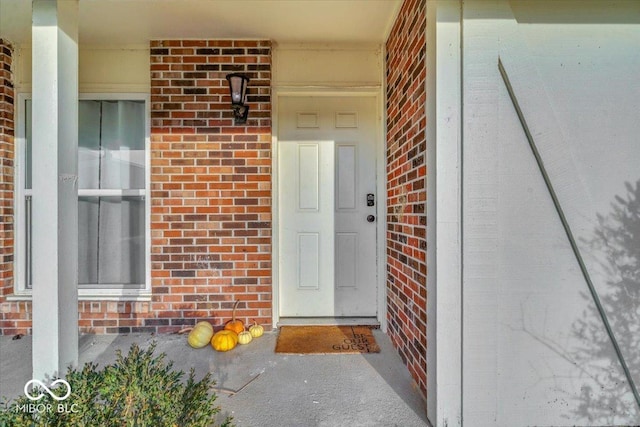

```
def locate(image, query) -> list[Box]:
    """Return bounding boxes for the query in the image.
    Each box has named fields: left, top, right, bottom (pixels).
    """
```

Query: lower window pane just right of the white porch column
left=78, top=197, right=145, bottom=285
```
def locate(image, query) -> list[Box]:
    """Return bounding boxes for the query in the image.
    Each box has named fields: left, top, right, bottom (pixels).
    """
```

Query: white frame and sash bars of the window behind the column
left=7, top=93, right=151, bottom=301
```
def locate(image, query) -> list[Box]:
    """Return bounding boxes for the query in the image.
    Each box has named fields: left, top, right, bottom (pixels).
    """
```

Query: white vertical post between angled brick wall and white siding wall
left=426, top=0, right=463, bottom=427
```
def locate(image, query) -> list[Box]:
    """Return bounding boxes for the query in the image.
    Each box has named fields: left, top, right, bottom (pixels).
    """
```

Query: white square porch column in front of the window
left=32, top=0, right=78, bottom=379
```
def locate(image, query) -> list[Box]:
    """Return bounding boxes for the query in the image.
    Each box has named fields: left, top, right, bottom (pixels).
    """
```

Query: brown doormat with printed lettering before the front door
left=276, top=326, right=380, bottom=354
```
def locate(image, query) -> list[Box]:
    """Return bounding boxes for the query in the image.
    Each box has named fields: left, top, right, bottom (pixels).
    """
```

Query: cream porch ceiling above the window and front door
left=0, top=0, right=402, bottom=45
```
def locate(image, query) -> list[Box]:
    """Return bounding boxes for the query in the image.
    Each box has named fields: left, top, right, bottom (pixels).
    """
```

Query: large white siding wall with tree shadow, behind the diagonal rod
left=463, top=1, right=640, bottom=427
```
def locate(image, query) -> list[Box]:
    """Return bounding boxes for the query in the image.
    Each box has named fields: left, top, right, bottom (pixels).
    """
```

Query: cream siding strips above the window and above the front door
left=15, top=44, right=383, bottom=93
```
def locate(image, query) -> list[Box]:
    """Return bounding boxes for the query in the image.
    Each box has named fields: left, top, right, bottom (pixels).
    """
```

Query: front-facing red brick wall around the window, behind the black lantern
left=0, top=40, right=272, bottom=335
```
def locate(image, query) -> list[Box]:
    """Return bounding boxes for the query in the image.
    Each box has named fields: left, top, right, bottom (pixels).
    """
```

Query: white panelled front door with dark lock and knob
left=278, top=96, right=378, bottom=317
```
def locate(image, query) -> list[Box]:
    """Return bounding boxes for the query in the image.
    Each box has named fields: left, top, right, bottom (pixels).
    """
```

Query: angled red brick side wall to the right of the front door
left=386, top=0, right=427, bottom=395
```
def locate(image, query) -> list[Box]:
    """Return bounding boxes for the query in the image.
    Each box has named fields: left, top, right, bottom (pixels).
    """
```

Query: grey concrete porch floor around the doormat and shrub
left=0, top=330, right=429, bottom=427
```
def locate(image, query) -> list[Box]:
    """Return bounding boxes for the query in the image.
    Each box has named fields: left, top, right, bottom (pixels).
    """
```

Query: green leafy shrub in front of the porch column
left=0, top=343, right=231, bottom=427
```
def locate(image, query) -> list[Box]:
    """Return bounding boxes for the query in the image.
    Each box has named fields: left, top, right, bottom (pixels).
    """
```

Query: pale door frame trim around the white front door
left=271, top=87, right=387, bottom=332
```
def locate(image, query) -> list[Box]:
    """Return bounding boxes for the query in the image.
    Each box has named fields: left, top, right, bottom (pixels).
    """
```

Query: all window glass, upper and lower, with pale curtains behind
left=23, top=100, right=146, bottom=288
